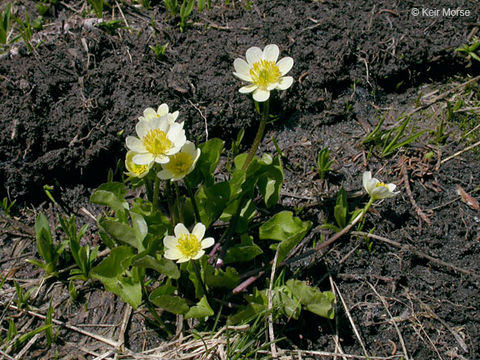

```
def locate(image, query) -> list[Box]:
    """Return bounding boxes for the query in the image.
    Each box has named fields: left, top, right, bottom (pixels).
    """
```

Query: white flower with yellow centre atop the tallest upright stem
left=233, top=44, right=293, bottom=102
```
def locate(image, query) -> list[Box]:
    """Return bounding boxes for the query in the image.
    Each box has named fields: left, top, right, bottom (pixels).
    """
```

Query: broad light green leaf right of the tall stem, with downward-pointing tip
left=259, top=211, right=312, bottom=262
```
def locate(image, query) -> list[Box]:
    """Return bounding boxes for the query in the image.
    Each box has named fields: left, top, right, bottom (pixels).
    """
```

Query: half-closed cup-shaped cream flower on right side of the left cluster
left=157, top=141, right=200, bottom=180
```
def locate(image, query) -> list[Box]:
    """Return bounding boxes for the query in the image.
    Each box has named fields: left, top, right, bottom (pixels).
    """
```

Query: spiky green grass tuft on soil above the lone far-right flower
left=362, top=116, right=425, bottom=157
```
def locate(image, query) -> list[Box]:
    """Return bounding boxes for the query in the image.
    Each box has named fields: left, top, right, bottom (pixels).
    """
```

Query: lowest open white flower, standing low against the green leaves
left=163, top=223, right=215, bottom=263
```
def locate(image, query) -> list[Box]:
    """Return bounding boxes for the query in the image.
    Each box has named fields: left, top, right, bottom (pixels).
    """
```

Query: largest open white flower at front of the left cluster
left=126, top=115, right=187, bottom=165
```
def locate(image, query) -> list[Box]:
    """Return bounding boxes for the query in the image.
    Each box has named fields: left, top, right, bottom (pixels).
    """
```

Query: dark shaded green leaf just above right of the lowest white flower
left=195, top=182, right=230, bottom=228
